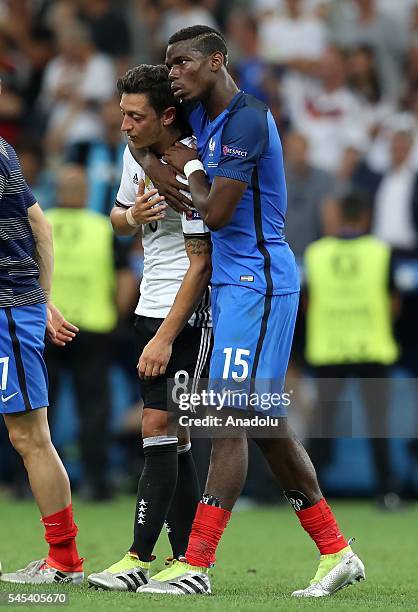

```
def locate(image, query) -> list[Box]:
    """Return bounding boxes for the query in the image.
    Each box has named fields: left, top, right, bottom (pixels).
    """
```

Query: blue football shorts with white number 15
left=208, top=285, right=299, bottom=416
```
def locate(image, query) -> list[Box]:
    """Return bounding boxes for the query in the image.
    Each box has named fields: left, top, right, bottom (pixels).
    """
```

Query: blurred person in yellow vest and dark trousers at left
left=46, top=165, right=127, bottom=500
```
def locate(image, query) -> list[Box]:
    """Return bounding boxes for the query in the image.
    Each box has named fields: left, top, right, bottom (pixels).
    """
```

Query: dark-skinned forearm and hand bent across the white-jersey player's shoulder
left=164, top=142, right=247, bottom=231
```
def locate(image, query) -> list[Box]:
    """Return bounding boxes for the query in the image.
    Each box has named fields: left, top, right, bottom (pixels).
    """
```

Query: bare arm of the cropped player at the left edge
left=28, top=203, right=78, bottom=346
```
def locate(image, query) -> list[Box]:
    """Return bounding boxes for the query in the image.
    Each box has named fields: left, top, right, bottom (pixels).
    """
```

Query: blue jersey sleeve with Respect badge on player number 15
left=215, top=107, right=268, bottom=183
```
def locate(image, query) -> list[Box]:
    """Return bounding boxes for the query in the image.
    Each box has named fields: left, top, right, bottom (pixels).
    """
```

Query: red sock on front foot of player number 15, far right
left=296, top=499, right=348, bottom=555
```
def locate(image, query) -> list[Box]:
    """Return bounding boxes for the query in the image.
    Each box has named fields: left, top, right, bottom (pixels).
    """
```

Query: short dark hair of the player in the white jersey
left=117, top=64, right=178, bottom=116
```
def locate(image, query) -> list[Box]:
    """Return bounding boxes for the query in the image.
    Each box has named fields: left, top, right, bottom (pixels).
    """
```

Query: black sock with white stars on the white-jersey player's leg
left=130, top=436, right=177, bottom=561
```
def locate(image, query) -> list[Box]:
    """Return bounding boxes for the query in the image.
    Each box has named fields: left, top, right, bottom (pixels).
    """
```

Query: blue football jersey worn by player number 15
left=187, top=92, right=299, bottom=295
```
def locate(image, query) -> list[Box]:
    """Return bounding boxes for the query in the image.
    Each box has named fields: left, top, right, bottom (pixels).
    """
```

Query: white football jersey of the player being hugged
left=116, top=137, right=212, bottom=327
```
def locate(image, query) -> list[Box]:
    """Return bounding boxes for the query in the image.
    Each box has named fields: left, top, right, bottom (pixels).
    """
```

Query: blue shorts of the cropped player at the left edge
left=0, top=304, right=48, bottom=414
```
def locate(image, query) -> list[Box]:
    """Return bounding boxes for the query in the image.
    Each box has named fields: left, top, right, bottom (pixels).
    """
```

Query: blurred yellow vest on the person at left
left=45, top=208, right=117, bottom=333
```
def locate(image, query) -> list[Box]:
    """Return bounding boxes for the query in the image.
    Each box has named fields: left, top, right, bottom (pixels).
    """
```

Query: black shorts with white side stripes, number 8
left=135, top=315, right=212, bottom=410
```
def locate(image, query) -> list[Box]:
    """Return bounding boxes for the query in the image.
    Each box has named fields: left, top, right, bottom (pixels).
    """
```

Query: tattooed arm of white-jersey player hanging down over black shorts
left=138, top=234, right=212, bottom=378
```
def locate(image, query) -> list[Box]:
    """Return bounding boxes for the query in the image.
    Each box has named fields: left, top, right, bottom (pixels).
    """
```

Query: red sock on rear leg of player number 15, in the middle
left=185, top=502, right=231, bottom=567
